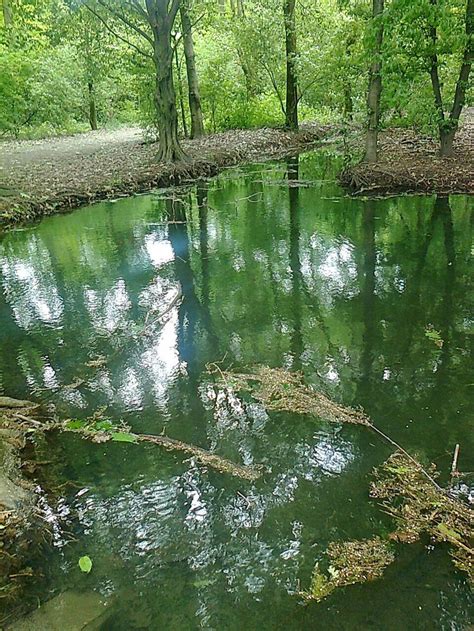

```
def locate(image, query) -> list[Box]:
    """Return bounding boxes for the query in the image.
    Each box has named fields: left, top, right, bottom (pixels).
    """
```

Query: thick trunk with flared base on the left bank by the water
left=146, top=0, right=186, bottom=162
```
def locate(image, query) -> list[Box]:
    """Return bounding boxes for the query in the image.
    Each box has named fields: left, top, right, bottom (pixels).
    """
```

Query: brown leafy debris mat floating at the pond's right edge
left=370, top=452, right=474, bottom=583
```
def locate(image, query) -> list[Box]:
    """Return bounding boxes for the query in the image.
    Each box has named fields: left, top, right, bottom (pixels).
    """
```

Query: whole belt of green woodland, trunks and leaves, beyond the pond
left=0, top=0, right=474, bottom=161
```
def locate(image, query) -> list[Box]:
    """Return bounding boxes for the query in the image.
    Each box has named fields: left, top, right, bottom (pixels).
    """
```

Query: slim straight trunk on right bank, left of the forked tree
left=364, top=0, right=384, bottom=162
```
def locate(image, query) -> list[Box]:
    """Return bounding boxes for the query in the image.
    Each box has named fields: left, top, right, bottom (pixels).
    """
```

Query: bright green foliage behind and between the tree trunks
left=0, top=0, right=474, bottom=137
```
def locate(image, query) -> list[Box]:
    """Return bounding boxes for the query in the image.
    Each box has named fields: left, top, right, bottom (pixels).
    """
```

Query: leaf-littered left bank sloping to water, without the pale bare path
left=0, top=125, right=340, bottom=231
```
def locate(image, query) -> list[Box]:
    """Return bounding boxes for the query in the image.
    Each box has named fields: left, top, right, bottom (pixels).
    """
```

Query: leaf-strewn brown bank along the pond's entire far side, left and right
left=0, top=122, right=474, bottom=232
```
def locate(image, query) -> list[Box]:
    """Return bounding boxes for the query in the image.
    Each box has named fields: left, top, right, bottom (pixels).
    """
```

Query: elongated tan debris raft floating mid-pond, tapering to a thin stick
left=209, top=364, right=372, bottom=427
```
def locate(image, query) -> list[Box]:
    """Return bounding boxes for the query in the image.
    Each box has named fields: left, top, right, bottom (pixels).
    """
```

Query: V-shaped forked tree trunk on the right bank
left=430, top=0, right=474, bottom=157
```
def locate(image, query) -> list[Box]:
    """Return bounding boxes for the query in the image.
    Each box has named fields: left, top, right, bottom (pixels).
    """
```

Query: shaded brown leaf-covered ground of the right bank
left=340, top=113, right=474, bottom=195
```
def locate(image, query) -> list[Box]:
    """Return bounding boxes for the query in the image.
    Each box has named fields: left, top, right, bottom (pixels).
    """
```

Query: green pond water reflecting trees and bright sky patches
left=0, top=154, right=474, bottom=631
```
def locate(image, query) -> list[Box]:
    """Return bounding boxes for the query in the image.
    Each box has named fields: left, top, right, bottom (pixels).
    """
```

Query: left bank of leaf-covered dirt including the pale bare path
left=0, top=124, right=335, bottom=227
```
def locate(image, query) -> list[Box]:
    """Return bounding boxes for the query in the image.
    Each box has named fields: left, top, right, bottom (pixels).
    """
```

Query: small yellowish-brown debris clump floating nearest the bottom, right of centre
left=300, top=537, right=395, bottom=602
